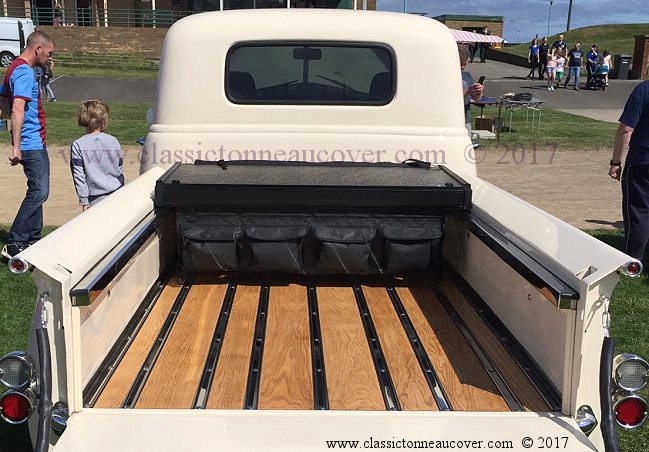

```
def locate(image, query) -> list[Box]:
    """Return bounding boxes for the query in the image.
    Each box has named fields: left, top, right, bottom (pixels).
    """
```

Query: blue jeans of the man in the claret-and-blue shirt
left=7, top=149, right=50, bottom=244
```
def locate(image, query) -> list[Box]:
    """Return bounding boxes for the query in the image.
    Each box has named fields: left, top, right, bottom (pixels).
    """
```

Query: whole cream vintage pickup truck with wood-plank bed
left=0, top=10, right=649, bottom=452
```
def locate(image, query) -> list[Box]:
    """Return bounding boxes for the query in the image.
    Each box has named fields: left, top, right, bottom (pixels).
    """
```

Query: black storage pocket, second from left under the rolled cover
left=245, top=222, right=309, bottom=273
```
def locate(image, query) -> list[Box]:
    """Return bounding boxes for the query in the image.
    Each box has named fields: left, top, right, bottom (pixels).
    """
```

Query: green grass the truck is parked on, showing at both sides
left=0, top=225, right=649, bottom=452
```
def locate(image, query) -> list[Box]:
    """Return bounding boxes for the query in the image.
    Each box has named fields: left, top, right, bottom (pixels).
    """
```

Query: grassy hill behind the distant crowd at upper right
left=502, top=24, right=649, bottom=58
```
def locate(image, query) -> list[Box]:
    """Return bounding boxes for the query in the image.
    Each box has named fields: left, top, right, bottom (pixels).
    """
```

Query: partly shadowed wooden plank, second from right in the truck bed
left=396, top=282, right=509, bottom=411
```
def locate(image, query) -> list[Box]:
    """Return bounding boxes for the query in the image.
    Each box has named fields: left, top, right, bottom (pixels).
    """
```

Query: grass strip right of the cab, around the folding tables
left=472, top=107, right=618, bottom=151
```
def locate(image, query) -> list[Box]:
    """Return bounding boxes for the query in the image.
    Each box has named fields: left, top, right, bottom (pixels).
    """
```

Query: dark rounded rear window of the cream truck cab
left=225, top=42, right=396, bottom=105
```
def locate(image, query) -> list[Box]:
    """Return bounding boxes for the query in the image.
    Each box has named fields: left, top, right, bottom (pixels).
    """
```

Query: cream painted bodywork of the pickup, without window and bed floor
left=3, top=10, right=644, bottom=451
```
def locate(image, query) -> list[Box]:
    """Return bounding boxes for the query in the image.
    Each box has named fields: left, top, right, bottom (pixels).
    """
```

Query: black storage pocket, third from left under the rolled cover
left=313, top=223, right=381, bottom=275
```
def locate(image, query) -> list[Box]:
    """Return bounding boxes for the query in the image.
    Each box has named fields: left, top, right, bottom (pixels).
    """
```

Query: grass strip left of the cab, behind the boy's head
left=0, top=102, right=151, bottom=147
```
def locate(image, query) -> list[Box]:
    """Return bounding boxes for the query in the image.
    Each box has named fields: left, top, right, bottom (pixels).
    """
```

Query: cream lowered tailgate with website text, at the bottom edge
left=54, top=409, right=595, bottom=452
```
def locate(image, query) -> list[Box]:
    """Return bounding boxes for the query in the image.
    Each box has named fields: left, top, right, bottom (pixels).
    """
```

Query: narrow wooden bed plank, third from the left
left=207, top=285, right=259, bottom=410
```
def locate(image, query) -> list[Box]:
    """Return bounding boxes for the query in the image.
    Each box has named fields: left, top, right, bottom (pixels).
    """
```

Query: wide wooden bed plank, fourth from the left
left=259, top=284, right=314, bottom=410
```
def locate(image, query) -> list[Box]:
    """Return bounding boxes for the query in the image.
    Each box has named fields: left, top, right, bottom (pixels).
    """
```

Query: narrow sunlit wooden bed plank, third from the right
left=363, top=286, right=438, bottom=411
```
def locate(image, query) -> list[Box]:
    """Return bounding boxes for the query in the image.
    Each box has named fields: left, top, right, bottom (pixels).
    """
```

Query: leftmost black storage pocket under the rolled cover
left=178, top=218, right=243, bottom=274
